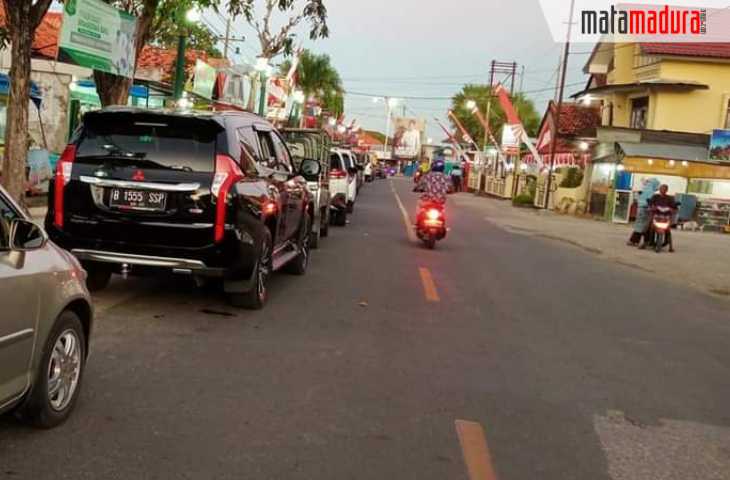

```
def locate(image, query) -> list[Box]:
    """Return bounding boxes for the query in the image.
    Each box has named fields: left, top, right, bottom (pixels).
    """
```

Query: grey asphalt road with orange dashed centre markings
left=0, top=179, right=730, bottom=480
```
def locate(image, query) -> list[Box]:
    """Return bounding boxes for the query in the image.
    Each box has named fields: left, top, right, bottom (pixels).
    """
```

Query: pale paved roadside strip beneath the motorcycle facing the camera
left=454, top=193, right=730, bottom=298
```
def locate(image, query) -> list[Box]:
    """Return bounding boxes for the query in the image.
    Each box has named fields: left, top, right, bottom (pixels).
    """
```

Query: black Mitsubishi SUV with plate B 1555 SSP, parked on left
left=46, top=107, right=321, bottom=309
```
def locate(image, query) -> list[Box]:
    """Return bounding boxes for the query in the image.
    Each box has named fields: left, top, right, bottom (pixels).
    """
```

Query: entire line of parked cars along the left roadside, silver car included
left=0, top=107, right=375, bottom=427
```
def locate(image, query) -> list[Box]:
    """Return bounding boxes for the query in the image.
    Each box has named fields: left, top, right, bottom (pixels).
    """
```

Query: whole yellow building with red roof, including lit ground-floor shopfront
left=576, top=42, right=730, bottom=225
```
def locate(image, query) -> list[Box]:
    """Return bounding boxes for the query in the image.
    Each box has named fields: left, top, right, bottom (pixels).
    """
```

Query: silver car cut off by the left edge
left=0, top=187, right=93, bottom=428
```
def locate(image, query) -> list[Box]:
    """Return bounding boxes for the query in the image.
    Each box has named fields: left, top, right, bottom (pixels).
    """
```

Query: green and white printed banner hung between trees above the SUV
left=58, top=0, right=137, bottom=78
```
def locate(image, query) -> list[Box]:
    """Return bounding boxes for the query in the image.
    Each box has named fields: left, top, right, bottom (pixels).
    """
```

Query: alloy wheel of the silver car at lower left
left=48, top=329, right=81, bottom=412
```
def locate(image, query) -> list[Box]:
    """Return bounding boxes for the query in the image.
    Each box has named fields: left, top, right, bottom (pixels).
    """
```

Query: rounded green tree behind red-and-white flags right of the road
left=451, top=84, right=540, bottom=147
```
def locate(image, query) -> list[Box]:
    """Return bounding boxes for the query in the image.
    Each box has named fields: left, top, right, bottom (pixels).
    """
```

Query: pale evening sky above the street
left=206, top=0, right=589, bottom=142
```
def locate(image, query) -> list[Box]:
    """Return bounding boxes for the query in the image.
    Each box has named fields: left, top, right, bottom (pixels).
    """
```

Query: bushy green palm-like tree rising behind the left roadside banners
left=281, top=50, right=345, bottom=117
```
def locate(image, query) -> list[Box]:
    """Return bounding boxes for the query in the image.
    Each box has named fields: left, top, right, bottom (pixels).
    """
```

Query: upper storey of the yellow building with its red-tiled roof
left=580, top=42, right=730, bottom=134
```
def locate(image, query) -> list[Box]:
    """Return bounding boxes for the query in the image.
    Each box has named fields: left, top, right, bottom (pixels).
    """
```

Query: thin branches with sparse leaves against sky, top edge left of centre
left=233, top=0, right=329, bottom=58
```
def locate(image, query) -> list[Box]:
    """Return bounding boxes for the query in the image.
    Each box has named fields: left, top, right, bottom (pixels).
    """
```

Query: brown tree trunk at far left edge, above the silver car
left=2, top=0, right=51, bottom=204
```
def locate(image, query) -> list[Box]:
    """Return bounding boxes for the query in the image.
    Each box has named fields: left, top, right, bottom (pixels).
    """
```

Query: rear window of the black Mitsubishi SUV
left=76, top=114, right=222, bottom=173
